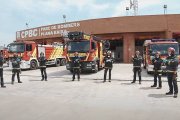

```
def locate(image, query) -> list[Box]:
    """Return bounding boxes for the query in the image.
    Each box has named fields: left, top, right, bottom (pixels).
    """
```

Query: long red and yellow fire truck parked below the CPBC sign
left=8, top=41, right=66, bottom=69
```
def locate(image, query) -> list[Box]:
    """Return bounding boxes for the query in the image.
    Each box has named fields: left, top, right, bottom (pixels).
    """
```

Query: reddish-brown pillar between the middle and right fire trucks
left=123, top=33, right=135, bottom=63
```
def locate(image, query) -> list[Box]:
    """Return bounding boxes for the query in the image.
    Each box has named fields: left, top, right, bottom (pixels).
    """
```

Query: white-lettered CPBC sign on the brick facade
left=16, top=22, right=80, bottom=40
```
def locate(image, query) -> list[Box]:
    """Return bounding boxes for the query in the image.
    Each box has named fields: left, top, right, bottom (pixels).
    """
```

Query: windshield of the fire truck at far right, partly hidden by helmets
left=150, top=44, right=179, bottom=55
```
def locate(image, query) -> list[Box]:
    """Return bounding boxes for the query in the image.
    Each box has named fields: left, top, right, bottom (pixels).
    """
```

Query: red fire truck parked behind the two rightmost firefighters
left=143, top=39, right=179, bottom=74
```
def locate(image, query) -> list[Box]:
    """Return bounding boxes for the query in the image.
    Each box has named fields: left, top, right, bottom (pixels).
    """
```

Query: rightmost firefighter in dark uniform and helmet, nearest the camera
left=165, top=47, right=178, bottom=98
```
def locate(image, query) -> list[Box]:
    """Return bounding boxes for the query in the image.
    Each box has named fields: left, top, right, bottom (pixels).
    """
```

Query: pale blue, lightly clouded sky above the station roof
left=0, top=0, right=180, bottom=46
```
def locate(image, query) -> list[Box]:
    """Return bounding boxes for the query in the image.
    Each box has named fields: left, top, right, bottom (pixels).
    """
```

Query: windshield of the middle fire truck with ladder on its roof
left=68, top=41, right=90, bottom=52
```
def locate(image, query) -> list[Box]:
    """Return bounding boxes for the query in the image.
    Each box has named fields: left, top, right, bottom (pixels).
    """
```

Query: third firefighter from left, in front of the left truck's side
left=38, top=52, right=47, bottom=81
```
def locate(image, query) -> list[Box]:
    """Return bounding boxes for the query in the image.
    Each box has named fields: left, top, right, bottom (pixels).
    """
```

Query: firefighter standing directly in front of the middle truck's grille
left=72, top=52, right=80, bottom=81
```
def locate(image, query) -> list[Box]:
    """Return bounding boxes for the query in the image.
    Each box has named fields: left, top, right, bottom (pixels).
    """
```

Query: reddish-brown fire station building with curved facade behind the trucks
left=16, top=14, right=180, bottom=63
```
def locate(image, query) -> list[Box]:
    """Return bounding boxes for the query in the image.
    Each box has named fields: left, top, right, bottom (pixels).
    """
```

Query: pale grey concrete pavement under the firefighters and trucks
left=0, top=64, right=180, bottom=120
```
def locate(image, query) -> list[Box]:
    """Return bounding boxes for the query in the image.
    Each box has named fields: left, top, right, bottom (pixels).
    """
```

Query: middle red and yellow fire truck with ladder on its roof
left=66, top=32, right=104, bottom=72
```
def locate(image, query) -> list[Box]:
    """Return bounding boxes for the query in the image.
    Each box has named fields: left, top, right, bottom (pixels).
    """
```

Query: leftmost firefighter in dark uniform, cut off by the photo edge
left=0, top=52, right=6, bottom=88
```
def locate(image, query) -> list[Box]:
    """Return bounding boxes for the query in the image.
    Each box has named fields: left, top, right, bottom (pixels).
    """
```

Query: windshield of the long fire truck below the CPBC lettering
left=8, top=44, right=25, bottom=53
